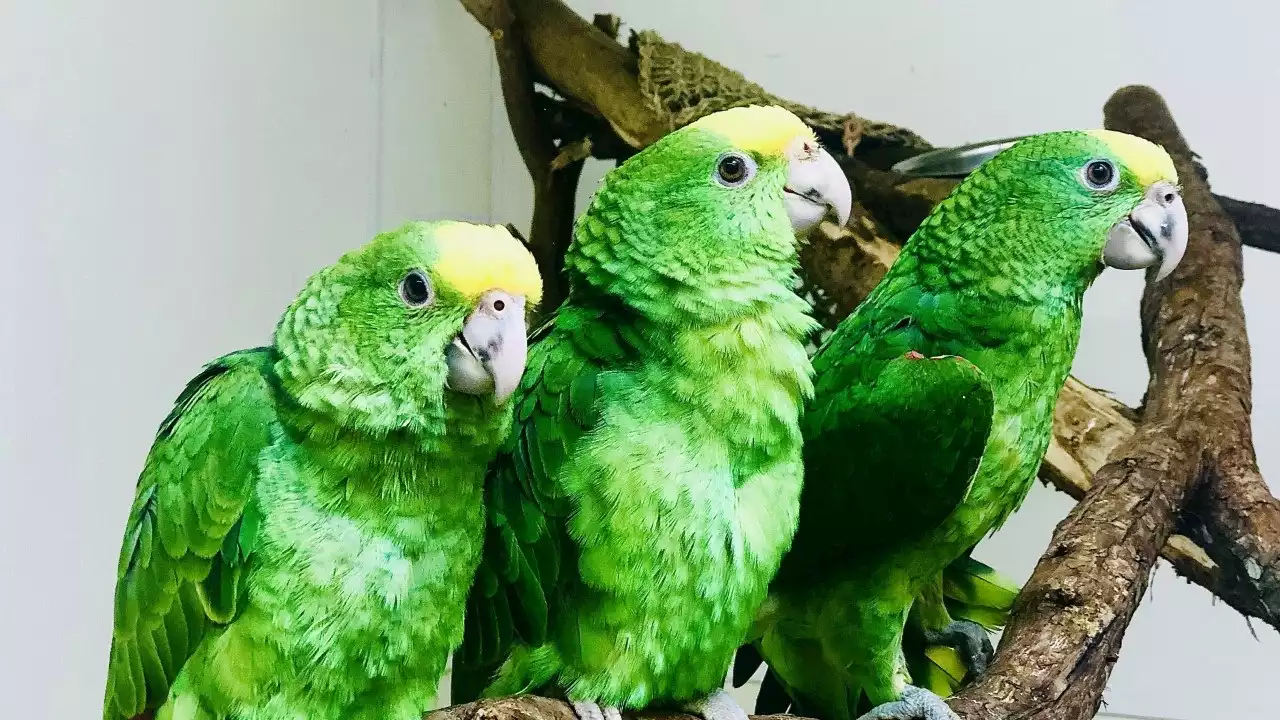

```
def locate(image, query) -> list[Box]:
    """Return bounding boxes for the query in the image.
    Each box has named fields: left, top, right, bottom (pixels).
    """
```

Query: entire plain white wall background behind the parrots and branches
left=0, top=0, right=1280, bottom=720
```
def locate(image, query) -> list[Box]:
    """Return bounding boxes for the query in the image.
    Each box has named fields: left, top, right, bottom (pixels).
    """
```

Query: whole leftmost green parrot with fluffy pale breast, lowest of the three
left=102, top=220, right=541, bottom=720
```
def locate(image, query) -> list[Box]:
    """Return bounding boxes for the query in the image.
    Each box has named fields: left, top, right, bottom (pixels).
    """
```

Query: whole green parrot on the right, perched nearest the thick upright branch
left=755, top=131, right=1188, bottom=720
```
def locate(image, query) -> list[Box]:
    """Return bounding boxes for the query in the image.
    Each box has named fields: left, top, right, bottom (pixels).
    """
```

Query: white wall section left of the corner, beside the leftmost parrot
left=0, top=0, right=492, bottom=720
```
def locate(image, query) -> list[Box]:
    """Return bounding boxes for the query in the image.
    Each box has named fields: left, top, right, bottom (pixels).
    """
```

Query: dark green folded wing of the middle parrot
left=452, top=306, right=635, bottom=702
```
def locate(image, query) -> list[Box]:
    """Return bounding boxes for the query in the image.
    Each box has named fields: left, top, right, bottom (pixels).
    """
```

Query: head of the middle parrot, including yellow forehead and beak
left=566, top=106, right=852, bottom=317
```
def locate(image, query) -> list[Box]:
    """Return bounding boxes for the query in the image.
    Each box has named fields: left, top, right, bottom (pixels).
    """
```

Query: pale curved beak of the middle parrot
left=782, top=138, right=854, bottom=236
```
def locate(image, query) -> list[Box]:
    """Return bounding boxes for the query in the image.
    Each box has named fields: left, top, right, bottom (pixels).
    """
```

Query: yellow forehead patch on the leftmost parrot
left=430, top=222, right=543, bottom=305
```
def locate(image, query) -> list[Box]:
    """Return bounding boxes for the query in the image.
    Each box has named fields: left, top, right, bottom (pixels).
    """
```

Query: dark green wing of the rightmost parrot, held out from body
left=785, top=278, right=995, bottom=571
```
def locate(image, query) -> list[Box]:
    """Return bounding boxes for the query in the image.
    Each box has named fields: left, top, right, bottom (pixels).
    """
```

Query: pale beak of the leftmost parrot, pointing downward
left=445, top=290, right=529, bottom=405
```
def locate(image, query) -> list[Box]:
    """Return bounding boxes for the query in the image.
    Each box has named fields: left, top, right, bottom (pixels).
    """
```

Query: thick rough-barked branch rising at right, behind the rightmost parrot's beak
left=951, top=87, right=1253, bottom=720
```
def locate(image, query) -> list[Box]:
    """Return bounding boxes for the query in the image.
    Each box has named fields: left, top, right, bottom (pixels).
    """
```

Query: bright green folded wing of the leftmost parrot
left=102, top=348, right=276, bottom=720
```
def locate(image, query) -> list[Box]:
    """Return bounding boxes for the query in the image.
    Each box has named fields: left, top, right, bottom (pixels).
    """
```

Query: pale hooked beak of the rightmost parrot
left=1102, top=182, right=1188, bottom=281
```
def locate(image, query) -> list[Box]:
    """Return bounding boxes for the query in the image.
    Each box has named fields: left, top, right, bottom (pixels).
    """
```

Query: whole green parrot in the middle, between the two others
left=452, top=106, right=852, bottom=720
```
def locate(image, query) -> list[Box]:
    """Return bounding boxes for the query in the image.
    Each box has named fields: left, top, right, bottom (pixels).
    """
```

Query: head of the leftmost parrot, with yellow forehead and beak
left=276, top=220, right=541, bottom=432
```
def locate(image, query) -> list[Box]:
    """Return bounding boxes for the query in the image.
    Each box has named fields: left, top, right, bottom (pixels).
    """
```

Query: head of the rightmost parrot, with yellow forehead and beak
left=951, top=129, right=1188, bottom=281
